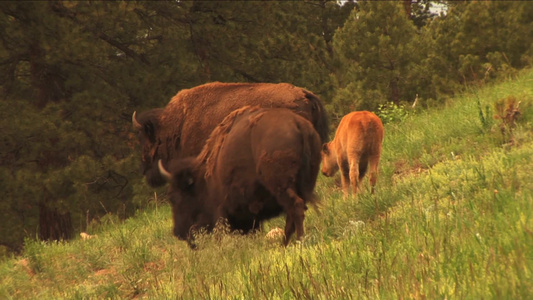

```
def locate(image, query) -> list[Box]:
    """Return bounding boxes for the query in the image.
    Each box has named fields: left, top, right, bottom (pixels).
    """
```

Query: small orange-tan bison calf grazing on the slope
left=321, top=111, right=383, bottom=197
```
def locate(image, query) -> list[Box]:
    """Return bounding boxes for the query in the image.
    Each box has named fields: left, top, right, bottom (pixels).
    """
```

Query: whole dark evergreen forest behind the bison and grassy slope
left=0, top=0, right=533, bottom=253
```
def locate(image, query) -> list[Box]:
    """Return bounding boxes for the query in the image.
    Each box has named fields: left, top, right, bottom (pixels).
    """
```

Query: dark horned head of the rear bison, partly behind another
left=131, top=109, right=165, bottom=187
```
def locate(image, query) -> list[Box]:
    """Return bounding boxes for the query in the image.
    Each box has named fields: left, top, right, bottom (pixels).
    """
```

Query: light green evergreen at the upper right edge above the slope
left=426, top=1, right=533, bottom=94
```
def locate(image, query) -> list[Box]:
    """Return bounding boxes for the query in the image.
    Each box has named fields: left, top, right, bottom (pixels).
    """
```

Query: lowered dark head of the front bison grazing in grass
left=158, top=158, right=214, bottom=247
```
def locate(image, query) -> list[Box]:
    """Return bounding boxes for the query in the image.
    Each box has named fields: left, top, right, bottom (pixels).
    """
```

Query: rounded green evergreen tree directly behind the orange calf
left=333, top=1, right=417, bottom=115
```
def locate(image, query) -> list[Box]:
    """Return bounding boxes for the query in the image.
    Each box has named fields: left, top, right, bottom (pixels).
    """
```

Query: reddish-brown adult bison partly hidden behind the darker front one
left=132, top=82, right=328, bottom=187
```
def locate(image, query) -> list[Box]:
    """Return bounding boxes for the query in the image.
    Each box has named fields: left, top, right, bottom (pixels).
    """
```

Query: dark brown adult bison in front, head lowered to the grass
left=159, top=106, right=321, bottom=245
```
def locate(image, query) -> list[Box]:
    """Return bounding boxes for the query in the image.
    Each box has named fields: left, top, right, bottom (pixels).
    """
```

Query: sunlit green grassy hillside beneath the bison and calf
left=0, top=71, right=533, bottom=299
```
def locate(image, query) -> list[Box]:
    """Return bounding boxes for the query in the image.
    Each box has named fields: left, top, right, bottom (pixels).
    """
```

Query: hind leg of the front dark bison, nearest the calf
left=282, top=188, right=305, bottom=246
